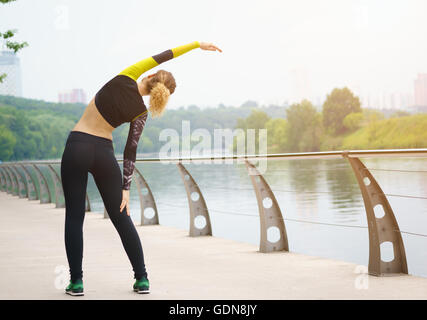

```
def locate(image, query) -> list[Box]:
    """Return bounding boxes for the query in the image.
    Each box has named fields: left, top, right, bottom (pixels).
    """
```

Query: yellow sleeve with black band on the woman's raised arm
left=119, top=41, right=200, bottom=81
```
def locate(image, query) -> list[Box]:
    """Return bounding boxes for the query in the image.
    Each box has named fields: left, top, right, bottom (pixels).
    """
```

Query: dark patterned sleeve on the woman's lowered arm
left=123, top=111, right=148, bottom=190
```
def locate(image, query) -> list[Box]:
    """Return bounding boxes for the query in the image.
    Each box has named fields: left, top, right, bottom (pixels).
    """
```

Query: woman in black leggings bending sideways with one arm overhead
left=61, top=41, right=222, bottom=295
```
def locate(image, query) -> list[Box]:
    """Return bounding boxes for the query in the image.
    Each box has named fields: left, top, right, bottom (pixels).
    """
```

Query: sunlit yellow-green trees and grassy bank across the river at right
left=234, top=87, right=427, bottom=153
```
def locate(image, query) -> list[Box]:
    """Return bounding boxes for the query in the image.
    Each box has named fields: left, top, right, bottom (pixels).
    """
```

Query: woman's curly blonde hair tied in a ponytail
left=147, top=70, right=176, bottom=118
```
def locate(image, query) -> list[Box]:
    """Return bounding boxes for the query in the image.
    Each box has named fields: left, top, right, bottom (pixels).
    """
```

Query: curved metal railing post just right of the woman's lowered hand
left=135, top=167, right=159, bottom=226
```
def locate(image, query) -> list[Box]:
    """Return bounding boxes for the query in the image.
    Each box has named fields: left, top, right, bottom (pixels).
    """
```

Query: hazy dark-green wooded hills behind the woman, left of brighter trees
left=0, top=95, right=283, bottom=161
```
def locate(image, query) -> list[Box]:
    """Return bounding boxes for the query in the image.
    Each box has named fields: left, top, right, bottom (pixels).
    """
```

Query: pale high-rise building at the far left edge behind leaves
left=0, top=51, right=22, bottom=97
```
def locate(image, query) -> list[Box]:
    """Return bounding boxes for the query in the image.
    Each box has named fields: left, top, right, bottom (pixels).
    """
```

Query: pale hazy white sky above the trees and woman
left=0, top=0, right=427, bottom=107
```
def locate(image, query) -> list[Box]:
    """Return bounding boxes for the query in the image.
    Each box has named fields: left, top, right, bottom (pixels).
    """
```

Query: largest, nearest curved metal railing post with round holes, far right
left=343, top=152, right=408, bottom=276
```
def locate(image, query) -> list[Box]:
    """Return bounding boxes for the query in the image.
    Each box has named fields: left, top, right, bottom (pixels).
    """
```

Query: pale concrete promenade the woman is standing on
left=0, top=192, right=427, bottom=300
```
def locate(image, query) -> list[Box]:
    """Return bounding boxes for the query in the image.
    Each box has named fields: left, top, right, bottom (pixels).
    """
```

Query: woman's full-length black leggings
left=61, top=131, right=147, bottom=281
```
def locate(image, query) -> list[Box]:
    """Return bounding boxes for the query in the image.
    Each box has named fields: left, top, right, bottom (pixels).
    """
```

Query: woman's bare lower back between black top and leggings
left=71, top=99, right=115, bottom=140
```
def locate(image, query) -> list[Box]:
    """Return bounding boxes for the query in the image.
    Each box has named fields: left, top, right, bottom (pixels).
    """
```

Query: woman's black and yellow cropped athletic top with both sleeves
left=95, top=41, right=200, bottom=190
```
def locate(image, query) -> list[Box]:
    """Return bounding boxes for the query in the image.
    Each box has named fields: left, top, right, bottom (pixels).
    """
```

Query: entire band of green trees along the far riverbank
left=0, top=88, right=427, bottom=161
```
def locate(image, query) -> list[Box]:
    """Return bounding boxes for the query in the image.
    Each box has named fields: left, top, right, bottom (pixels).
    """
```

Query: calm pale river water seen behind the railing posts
left=84, top=158, right=427, bottom=277
